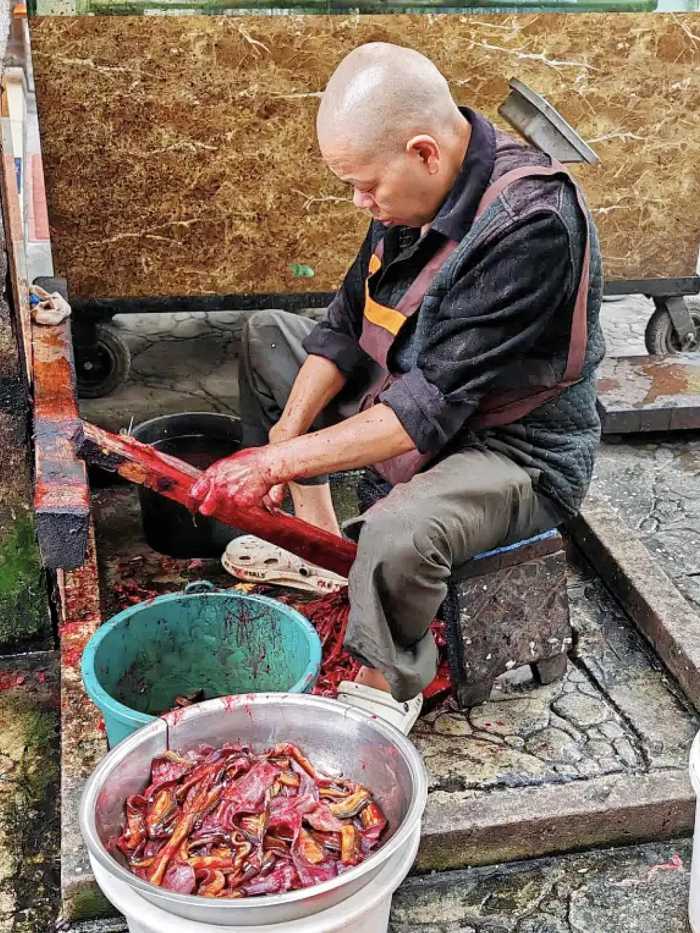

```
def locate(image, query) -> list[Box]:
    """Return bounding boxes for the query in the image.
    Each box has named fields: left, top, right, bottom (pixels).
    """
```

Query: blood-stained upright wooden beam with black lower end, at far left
left=32, top=321, right=90, bottom=569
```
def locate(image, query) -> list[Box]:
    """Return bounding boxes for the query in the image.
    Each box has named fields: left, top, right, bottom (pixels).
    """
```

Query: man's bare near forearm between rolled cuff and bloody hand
left=265, top=404, right=415, bottom=483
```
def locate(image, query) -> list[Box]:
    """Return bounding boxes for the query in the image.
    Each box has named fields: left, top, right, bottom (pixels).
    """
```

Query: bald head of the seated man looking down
left=316, top=42, right=471, bottom=227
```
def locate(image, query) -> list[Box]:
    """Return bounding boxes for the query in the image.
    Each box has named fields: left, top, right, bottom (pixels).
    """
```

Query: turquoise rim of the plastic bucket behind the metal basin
left=80, top=587, right=322, bottom=728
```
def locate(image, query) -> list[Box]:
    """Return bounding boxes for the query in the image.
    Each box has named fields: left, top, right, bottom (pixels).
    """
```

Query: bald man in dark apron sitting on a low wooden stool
left=195, top=43, right=604, bottom=732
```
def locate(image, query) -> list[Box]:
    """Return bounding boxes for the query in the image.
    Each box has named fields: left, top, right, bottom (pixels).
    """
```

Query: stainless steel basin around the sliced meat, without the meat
left=80, top=693, right=427, bottom=926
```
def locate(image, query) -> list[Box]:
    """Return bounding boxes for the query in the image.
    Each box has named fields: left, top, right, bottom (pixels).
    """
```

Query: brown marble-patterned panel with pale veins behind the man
left=32, top=14, right=700, bottom=296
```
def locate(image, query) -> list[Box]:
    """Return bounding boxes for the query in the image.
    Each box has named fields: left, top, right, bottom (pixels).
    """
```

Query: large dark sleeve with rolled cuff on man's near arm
left=379, top=212, right=583, bottom=453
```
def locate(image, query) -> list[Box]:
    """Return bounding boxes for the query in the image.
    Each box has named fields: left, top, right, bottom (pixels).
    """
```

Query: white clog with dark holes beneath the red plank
left=221, top=535, right=348, bottom=593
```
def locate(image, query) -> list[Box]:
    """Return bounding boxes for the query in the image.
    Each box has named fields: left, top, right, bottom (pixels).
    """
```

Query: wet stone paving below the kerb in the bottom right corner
left=389, top=839, right=691, bottom=933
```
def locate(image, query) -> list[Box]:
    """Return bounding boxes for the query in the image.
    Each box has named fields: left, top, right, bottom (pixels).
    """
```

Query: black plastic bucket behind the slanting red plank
left=131, top=411, right=241, bottom=557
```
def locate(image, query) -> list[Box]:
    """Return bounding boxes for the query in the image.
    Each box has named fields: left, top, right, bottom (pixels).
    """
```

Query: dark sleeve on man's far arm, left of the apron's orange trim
left=302, top=224, right=374, bottom=376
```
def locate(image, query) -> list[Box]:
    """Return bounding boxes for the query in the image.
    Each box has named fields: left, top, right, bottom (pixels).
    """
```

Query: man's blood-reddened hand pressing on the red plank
left=191, top=447, right=284, bottom=515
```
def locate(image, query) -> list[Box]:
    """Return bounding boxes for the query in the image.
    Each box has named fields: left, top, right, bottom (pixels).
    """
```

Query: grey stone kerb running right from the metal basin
left=415, top=770, right=695, bottom=872
